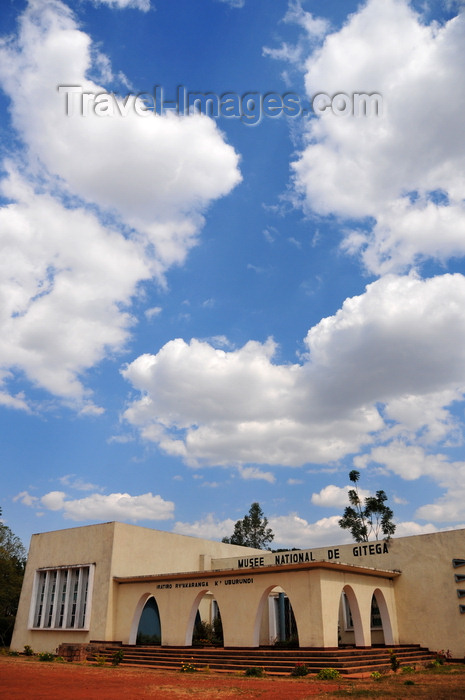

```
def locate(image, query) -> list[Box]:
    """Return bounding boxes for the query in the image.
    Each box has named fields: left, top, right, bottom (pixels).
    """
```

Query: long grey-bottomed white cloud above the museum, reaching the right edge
left=123, top=275, right=465, bottom=476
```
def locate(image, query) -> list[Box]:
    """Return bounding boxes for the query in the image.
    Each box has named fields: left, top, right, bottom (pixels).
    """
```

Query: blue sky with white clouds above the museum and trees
left=0, top=0, right=465, bottom=548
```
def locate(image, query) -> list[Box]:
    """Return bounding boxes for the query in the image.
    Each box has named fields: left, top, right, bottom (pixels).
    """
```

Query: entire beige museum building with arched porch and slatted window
left=11, top=522, right=465, bottom=659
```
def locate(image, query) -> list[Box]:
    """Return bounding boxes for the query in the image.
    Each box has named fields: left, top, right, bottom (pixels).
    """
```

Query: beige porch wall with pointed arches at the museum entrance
left=115, top=569, right=397, bottom=647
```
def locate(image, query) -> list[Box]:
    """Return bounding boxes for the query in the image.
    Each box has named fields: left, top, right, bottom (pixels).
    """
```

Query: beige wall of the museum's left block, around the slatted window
left=11, top=522, right=259, bottom=651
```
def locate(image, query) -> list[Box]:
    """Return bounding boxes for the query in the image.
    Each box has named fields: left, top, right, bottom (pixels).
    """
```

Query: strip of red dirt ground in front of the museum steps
left=0, top=656, right=465, bottom=700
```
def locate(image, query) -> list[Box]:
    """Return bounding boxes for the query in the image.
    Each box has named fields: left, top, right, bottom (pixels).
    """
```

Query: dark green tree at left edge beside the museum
left=0, top=509, right=26, bottom=646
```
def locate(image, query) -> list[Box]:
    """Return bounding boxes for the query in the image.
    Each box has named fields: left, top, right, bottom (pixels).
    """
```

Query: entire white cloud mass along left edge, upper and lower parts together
left=0, top=0, right=240, bottom=404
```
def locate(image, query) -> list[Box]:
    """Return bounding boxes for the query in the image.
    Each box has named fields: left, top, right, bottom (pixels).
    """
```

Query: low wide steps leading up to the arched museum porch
left=87, top=643, right=436, bottom=676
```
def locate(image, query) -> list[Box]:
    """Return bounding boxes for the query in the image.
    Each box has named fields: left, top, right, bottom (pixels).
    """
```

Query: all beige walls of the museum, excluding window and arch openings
left=12, top=523, right=465, bottom=658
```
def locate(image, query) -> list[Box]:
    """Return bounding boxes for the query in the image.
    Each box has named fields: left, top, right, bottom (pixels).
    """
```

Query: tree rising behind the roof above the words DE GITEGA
left=339, top=469, right=396, bottom=542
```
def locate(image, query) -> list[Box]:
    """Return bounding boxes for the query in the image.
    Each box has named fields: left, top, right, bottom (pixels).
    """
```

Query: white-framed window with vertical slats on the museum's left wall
left=28, top=564, right=95, bottom=632
